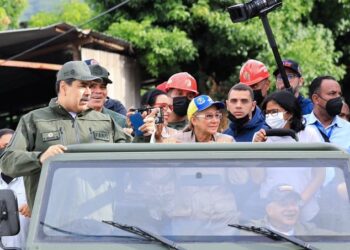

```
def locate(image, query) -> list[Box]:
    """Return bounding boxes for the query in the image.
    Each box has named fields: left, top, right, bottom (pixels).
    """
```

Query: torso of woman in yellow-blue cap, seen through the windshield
left=163, top=167, right=241, bottom=236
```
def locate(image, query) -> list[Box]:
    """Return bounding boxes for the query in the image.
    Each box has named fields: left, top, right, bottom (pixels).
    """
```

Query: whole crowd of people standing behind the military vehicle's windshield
left=0, top=57, right=350, bottom=246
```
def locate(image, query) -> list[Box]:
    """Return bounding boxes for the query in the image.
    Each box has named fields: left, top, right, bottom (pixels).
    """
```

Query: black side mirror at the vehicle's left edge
left=0, top=189, right=20, bottom=249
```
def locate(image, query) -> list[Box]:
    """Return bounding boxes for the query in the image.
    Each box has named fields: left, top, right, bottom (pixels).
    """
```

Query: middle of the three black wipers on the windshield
left=102, top=220, right=184, bottom=250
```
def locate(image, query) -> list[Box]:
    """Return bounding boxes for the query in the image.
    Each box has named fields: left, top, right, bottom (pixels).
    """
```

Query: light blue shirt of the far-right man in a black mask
left=305, top=112, right=350, bottom=153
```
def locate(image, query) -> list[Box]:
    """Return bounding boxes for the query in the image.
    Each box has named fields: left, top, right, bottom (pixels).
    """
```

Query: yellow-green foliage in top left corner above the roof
left=0, top=0, right=28, bottom=30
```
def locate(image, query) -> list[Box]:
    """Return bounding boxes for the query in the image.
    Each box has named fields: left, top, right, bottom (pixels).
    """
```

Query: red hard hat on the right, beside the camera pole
left=239, top=59, right=270, bottom=86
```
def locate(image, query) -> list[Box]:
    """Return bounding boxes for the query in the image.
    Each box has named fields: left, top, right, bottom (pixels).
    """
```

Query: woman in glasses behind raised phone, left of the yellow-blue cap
left=141, top=89, right=178, bottom=138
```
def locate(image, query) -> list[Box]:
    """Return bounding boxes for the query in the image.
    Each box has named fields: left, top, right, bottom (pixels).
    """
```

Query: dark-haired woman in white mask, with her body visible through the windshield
left=253, top=90, right=325, bottom=222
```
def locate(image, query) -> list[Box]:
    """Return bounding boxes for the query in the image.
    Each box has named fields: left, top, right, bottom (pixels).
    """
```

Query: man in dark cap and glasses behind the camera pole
left=273, top=59, right=313, bottom=115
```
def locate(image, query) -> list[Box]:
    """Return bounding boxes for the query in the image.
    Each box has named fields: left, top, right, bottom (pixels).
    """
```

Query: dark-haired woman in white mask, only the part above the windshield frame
left=253, top=90, right=322, bottom=142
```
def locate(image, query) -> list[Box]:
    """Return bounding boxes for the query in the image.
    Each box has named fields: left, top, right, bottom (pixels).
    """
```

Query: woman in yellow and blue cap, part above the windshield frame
left=157, top=95, right=234, bottom=143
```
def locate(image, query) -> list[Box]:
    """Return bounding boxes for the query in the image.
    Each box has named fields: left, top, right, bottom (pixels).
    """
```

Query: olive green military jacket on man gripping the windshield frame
left=0, top=102, right=132, bottom=208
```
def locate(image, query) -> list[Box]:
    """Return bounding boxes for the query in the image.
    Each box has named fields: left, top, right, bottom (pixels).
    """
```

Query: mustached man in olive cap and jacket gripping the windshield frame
left=0, top=61, right=154, bottom=208
